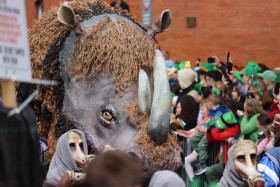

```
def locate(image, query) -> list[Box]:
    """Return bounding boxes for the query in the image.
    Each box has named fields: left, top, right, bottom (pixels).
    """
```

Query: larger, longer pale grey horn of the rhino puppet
left=148, top=49, right=171, bottom=144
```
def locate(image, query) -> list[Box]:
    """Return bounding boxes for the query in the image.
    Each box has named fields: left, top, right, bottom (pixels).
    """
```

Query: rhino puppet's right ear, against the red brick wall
left=147, top=10, right=172, bottom=36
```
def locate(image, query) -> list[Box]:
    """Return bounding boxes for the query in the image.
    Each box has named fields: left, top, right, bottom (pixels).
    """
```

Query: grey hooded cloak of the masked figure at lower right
left=218, top=146, right=248, bottom=187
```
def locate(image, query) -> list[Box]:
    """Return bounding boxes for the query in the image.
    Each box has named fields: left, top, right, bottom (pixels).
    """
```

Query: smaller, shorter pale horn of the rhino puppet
left=138, top=69, right=152, bottom=114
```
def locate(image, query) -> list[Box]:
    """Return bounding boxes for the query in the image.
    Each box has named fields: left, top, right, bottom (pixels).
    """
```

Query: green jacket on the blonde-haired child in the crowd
left=240, top=114, right=259, bottom=142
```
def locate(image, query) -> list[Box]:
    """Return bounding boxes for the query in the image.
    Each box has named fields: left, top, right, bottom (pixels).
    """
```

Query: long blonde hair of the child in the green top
left=244, top=98, right=264, bottom=120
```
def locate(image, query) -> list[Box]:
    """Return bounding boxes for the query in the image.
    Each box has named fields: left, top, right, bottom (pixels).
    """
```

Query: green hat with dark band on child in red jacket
left=215, top=112, right=237, bottom=129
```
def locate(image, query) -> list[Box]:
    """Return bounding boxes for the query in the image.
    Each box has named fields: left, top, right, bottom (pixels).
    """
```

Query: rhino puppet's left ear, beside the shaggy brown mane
left=57, top=2, right=83, bottom=34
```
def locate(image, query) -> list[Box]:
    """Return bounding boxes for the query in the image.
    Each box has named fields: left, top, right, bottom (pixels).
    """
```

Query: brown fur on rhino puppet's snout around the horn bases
left=126, top=100, right=181, bottom=160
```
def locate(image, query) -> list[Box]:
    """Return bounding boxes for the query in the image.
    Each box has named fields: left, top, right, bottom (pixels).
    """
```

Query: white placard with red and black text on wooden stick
left=0, top=0, right=32, bottom=81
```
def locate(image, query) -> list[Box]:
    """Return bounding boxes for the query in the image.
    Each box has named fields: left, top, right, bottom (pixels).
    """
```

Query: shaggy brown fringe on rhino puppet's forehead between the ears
left=70, top=17, right=156, bottom=94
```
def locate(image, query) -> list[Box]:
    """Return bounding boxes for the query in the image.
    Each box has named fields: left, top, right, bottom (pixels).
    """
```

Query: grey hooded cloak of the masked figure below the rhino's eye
left=43, top=129, right=88, bottom=187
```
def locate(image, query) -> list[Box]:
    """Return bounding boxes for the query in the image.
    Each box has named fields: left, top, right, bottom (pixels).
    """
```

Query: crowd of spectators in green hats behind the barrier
left=166, top=50, right=280, bottom=186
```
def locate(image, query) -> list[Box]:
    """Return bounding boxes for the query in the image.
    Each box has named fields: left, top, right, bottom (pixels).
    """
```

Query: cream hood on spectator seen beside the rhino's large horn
left=177, top=68, right=198, bottom=103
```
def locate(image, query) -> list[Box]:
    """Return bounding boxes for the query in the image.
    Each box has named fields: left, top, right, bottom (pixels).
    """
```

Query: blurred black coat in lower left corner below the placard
left=0, top=105, right=42, bottom=187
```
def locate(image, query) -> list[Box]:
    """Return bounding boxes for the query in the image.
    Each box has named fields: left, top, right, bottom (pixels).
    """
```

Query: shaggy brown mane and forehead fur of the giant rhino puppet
left=29, top=0, right=156, bottom=161
